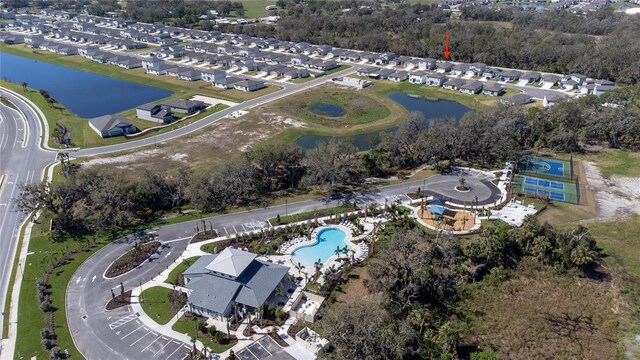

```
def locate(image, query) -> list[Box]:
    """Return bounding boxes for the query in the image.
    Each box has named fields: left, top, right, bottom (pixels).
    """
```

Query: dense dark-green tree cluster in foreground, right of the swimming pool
left=322, top=217, right=598, bottom=360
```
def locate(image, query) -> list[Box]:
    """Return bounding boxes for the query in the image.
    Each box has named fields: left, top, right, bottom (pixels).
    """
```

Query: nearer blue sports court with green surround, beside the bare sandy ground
left=513, top=175, right=578, bottom=204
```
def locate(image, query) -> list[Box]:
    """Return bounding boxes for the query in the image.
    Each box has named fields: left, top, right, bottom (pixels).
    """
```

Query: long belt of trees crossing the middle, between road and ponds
left=15, top=85, right=640, bottom=239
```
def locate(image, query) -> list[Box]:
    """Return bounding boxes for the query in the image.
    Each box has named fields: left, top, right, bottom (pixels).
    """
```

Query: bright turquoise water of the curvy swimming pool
left=291, top=228, right=347, bottom=267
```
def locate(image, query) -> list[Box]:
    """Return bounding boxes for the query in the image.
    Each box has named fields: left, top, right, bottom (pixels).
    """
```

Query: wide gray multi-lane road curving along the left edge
left=0, top=92, right=55, bottom=338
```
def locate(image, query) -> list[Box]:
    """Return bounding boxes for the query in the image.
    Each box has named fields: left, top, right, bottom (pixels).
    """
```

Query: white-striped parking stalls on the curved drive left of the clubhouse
left=107, top=313, right=191, bottom=360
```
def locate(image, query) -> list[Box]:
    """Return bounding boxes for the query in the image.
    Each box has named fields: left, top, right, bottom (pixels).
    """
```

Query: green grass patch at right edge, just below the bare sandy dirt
left=587, top=214, right=640, bottom=279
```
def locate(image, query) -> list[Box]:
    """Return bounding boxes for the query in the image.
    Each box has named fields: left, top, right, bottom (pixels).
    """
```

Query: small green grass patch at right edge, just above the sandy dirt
left=583, top=149, right=640, bottom=178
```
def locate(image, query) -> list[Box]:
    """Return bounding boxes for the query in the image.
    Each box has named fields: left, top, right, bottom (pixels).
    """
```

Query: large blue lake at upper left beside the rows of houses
left=0, top=52, right=172, bottom=118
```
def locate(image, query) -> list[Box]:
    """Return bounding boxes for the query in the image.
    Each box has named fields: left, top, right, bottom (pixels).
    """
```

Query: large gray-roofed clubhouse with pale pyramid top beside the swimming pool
left=183, top=247, right=289, bottom=319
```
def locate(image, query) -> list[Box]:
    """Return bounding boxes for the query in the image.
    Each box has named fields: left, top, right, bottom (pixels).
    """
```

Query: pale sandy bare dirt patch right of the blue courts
left=583, top=161, right=640, bottom=221
